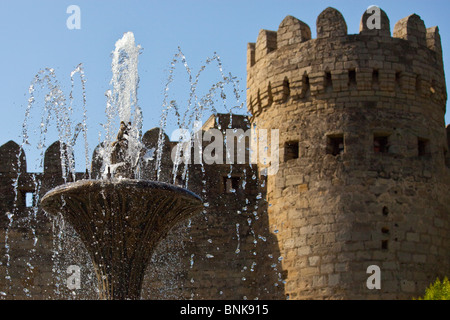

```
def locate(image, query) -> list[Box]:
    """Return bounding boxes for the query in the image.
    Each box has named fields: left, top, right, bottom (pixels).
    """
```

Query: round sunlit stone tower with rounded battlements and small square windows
left=247, top=8, right=450, bottom=299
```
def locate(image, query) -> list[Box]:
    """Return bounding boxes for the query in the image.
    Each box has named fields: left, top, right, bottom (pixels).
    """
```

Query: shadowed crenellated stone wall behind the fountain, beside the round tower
left=0, top=114, right=284, bottom=299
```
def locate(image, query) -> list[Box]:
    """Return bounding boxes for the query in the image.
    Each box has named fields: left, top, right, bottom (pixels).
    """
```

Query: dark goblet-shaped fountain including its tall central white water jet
left=41, top=33, right=203, bottom=300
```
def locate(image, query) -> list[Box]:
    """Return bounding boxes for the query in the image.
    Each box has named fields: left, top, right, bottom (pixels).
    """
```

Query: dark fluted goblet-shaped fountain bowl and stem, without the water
left=41, top=179, right=203, bottom=300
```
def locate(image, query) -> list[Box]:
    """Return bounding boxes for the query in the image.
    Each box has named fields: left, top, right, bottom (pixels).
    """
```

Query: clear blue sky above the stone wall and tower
left=0, top=0, right=450, bottom=170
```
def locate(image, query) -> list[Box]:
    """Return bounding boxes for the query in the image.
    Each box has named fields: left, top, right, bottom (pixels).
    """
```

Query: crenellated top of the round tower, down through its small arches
left=247, top=8, right=447, bottom=116
